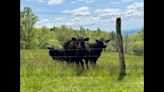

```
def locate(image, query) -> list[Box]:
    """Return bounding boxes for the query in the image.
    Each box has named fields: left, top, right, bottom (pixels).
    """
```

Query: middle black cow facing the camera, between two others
left=63, top=38, right=89, bottom=69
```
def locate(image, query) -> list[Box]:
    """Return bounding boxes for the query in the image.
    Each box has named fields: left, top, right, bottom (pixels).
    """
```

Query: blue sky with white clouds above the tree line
left=21, top=0, right=144, bottom=31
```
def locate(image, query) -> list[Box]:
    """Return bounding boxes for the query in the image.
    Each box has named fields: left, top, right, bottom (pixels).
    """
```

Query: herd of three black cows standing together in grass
left=48, top=37, right=110, bottom=69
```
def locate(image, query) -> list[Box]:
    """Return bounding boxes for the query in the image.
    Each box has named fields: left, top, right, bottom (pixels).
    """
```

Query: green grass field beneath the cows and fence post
left=20, top=49, right=144, bottom=92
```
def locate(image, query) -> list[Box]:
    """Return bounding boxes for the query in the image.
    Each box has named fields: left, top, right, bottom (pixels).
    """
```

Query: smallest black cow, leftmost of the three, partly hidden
left=47, top=47, right=66, bottom=61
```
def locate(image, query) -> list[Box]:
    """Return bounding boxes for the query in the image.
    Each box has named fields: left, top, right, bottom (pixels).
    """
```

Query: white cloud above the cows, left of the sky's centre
left=63, top=7, right=90, bottom=16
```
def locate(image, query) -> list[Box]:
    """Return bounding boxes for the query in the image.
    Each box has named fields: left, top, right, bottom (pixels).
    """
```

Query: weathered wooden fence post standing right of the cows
left=116, top=18, right=126, bottom=80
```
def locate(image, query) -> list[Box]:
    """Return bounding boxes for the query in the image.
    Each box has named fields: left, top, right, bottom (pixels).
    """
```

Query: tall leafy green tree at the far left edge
left=20, top=6, right=38, bottom=48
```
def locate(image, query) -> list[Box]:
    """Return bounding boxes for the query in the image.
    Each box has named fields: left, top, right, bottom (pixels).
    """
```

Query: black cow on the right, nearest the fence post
left=83, top=39, right=110, bottom=68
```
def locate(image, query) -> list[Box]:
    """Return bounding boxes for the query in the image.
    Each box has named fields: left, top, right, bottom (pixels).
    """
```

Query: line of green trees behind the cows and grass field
left=20, top=6, right=144, bottom=55
